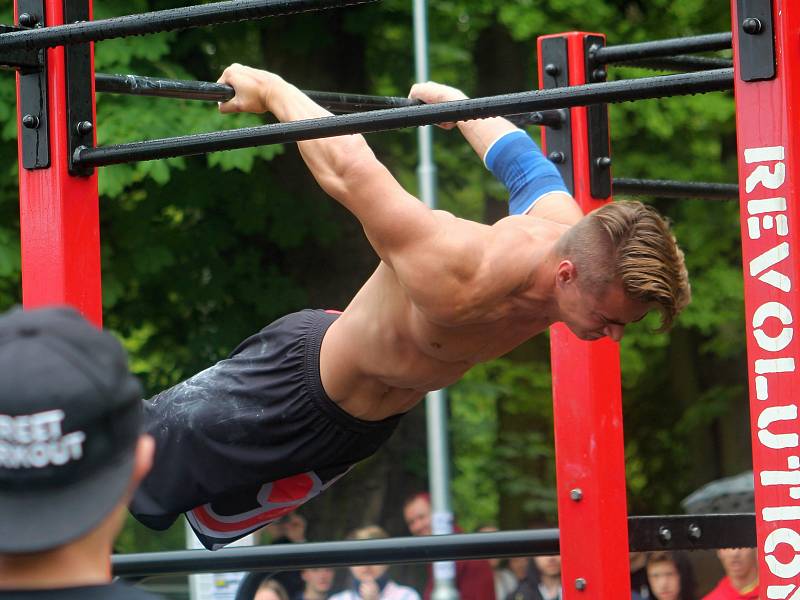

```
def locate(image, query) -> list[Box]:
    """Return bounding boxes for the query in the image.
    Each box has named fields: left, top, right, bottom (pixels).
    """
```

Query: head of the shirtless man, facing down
left=555, top=202, right=691, bottom=340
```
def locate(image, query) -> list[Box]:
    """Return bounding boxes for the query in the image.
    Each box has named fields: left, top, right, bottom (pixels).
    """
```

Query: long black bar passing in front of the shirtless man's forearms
left=74, top=69, right=733, bottom=167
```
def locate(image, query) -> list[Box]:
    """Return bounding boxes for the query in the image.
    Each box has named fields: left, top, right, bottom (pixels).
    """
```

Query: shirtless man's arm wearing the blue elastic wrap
left=409, top=82, right=583, bottom=225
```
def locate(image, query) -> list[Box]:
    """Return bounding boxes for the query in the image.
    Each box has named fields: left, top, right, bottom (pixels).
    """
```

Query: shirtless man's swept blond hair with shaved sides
left=557, top=201, right=691, bottom=331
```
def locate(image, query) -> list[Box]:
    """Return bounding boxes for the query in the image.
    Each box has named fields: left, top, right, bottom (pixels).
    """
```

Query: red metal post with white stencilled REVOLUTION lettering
left=731, top=0, right=800, bottom=600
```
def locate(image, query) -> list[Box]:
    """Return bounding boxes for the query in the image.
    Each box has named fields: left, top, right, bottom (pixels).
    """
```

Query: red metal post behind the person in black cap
left=14, top=0, right=102, bottom=326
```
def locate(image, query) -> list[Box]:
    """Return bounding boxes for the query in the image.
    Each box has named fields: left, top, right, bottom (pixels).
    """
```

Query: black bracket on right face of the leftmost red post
left=64, top=0, right=94, bottom=177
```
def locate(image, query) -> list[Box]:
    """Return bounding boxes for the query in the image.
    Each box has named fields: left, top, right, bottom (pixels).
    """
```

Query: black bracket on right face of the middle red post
left=583, top=35, right=611, bottom=199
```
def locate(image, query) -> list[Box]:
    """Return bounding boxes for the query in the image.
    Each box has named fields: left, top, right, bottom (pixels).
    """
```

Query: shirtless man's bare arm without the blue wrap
left=219, top=65, right=492, bottom=315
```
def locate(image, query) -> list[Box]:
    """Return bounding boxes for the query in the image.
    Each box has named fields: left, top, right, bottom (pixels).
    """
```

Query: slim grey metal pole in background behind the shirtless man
left=414, top=0, right=458, bottom=600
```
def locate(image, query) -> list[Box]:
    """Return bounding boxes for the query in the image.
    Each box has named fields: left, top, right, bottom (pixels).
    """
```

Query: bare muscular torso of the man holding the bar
left=320, top=211, right=566, bottom=420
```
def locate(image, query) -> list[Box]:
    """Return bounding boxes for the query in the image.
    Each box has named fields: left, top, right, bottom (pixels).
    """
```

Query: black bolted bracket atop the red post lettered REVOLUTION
left=736, top=0, right=775, bottom=81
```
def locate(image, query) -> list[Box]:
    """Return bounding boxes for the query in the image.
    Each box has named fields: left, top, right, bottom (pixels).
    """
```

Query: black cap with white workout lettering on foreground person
left=0, top=307, right=142, bottom=554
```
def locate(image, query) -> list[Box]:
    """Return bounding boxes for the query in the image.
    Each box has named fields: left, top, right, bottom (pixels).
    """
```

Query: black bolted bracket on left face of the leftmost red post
left=15, top=0, right=50, bottom=169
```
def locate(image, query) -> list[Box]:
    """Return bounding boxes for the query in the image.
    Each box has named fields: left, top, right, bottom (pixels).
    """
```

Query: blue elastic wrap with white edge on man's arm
left=485, top=130, right=569, bottom=215
